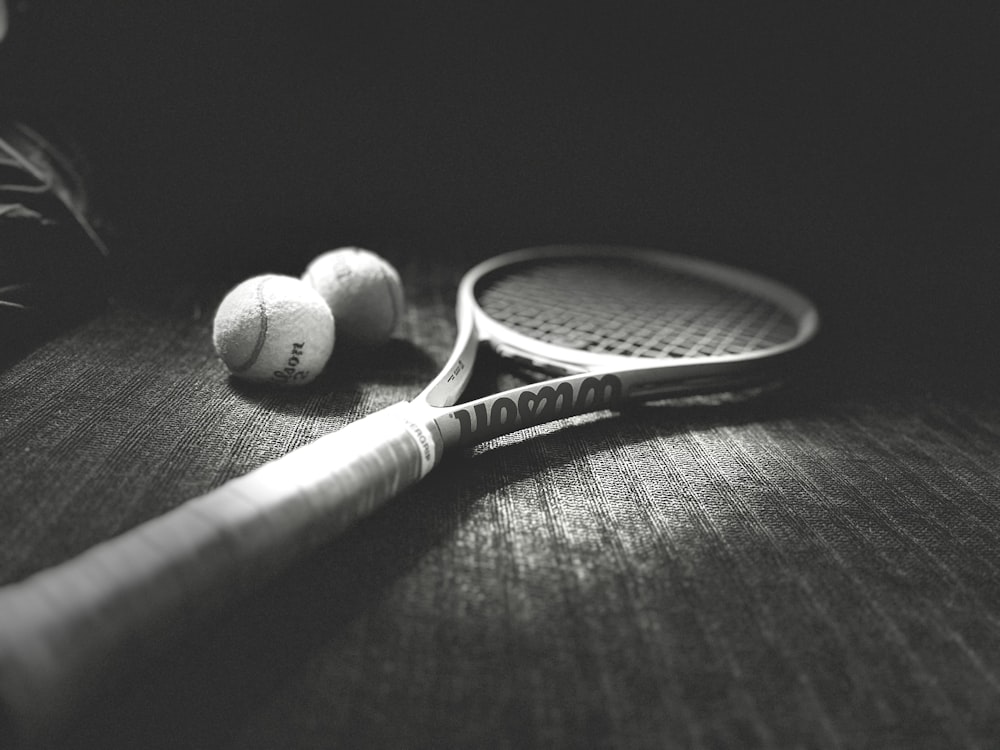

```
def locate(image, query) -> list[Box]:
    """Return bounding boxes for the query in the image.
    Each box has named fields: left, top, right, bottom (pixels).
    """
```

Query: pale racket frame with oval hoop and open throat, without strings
left=411, top=245, right=819, bottom=452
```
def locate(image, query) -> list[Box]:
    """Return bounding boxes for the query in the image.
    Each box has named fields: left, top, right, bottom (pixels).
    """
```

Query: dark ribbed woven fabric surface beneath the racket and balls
left=0, top=254, right=1000, bottom=748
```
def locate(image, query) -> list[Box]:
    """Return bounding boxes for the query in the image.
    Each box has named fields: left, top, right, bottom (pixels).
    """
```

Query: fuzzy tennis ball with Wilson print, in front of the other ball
left=212, top=274, right=335, bottom=385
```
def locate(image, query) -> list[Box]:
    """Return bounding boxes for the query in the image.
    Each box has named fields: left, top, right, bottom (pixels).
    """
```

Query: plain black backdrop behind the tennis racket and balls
left=3, top=0, right=1000, bottom=376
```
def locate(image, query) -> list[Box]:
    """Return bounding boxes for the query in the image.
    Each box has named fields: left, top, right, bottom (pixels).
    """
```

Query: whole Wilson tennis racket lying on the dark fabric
left=0, top=246, right=818, bottom=737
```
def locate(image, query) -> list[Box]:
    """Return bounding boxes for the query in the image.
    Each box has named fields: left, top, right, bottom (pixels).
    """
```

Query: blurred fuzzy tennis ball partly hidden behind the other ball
left=302, top=247, right=404, bottom=348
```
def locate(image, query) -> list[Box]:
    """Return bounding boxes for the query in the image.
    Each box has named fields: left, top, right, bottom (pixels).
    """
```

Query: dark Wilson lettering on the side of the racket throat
left=451, top=375, right=622, bottom=442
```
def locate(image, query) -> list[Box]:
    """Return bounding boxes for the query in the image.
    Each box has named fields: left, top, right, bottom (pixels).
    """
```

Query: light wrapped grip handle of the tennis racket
left=0, top=403, right=435, bottom=747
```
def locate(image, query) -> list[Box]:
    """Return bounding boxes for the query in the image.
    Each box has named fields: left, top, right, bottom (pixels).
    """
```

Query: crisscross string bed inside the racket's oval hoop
left=476, top=258, right=798, bottom=358
